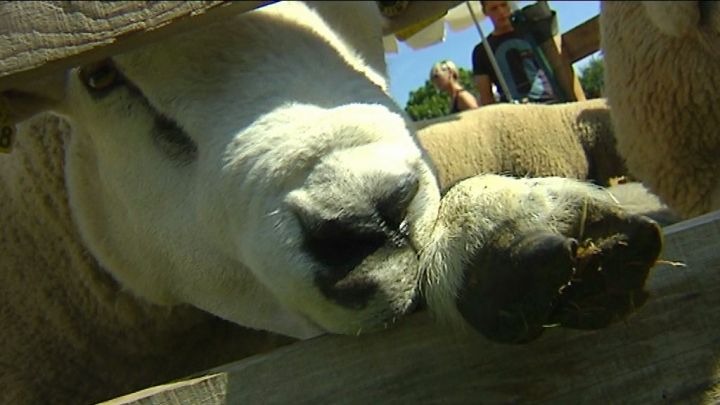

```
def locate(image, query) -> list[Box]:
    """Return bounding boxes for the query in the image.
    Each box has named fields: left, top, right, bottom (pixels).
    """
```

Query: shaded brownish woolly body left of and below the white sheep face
left=0, top=115, right=294, bottom=404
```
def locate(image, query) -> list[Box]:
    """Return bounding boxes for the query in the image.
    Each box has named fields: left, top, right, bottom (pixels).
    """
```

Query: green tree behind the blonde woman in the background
left=405, top=68, right=479, bottom=121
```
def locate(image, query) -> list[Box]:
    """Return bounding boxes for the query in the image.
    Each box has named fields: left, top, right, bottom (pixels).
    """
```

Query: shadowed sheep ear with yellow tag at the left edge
left=0, top=73, right=66, bottom=153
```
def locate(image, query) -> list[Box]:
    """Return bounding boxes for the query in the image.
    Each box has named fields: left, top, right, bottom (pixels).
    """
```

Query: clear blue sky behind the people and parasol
left=385, top=1, right=600, bottom=107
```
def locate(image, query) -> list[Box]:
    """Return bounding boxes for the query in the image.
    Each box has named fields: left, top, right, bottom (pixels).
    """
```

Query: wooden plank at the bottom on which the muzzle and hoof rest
left=104, top=212, right=720, bottom=404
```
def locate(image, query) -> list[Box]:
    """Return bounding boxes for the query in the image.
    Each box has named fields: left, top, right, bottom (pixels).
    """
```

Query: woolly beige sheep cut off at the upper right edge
left=600, top=2, right=720, bottom=218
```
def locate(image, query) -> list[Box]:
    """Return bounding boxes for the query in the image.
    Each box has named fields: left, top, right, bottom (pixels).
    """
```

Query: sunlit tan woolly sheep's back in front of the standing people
left=416, top=99, right=628, bottom=189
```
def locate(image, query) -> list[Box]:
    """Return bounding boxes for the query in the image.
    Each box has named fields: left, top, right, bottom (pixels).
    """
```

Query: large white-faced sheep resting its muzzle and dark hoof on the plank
left=0, top=2, right=661, bottom=403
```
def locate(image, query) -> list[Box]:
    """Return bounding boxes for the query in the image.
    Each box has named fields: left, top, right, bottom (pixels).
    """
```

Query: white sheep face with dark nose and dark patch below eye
left=50, top=2, right=439, bottom=337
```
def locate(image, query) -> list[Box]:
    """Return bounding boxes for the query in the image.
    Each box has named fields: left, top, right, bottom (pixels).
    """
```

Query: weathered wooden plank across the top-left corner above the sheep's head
left=0, top=1, right=272, bottom=90
